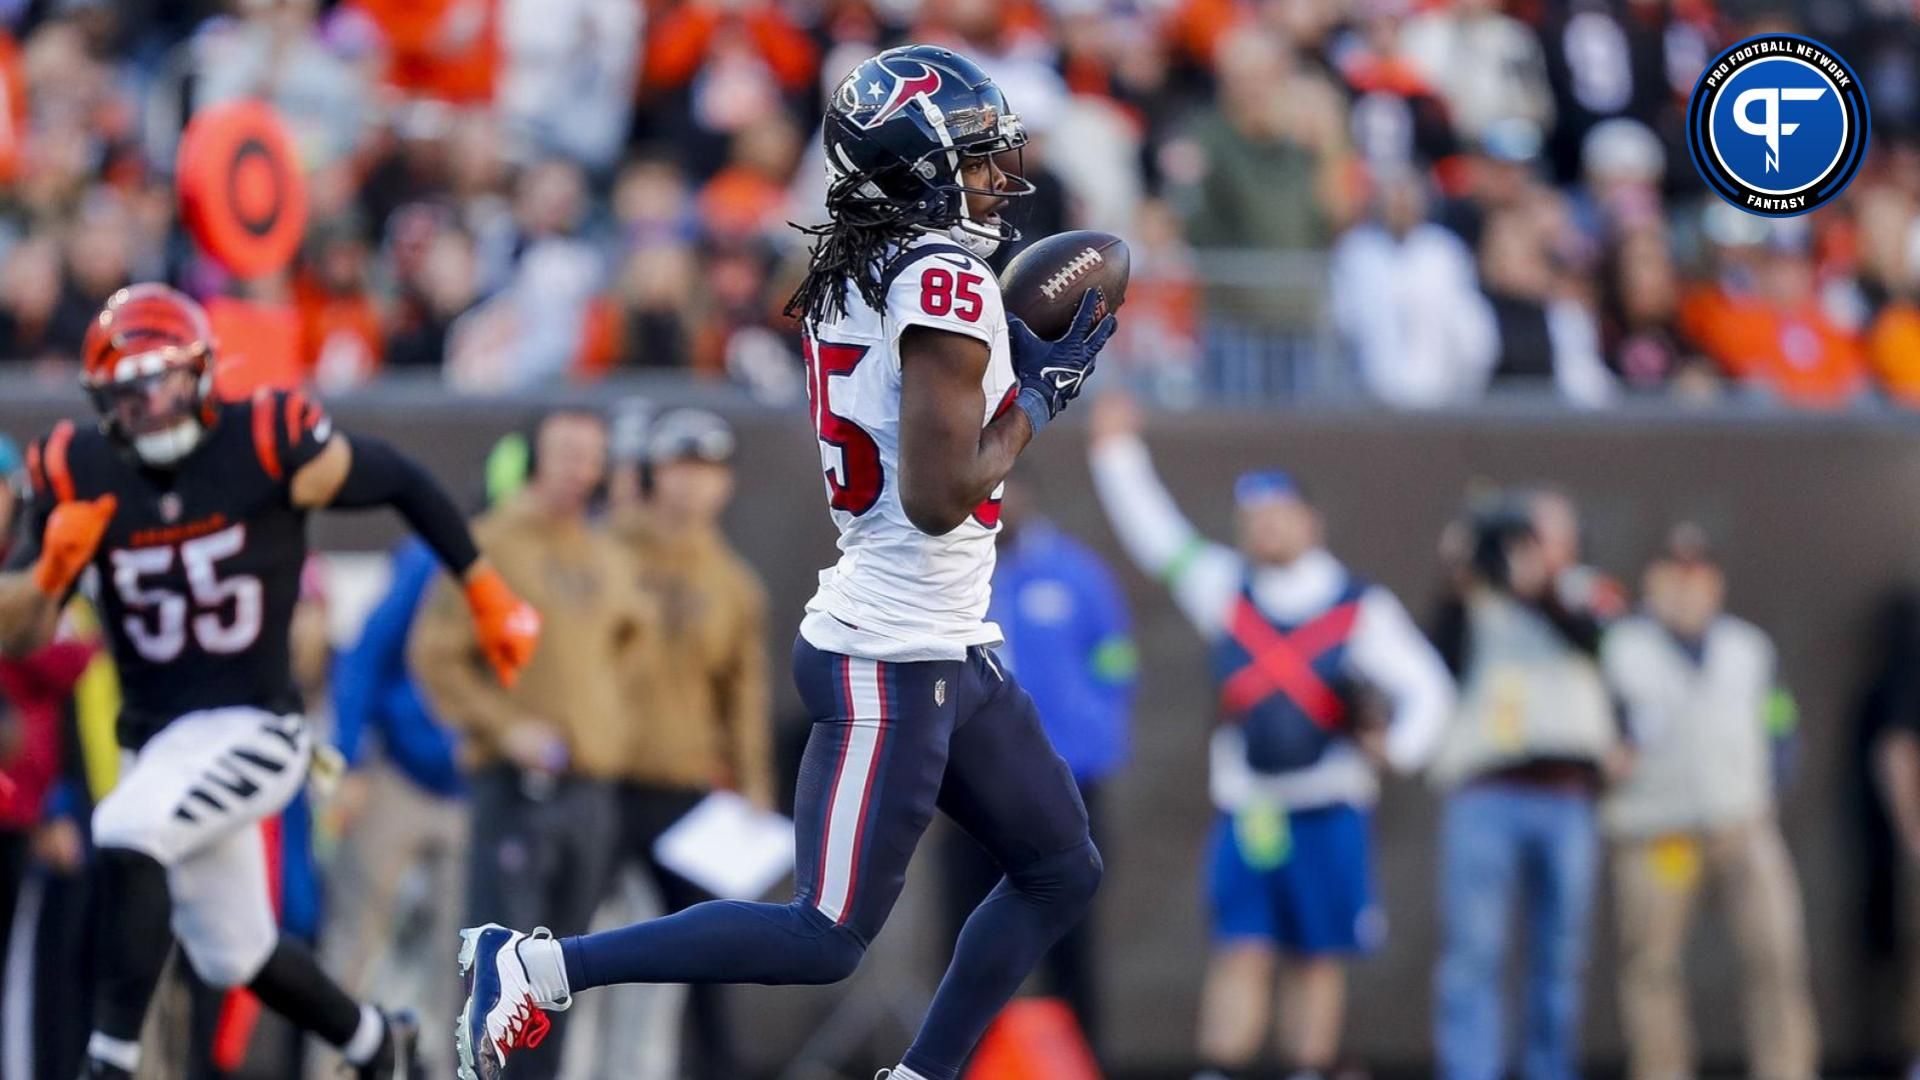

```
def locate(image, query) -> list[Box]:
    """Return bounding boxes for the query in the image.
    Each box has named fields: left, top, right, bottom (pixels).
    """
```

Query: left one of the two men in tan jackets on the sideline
left=407, top=411, right=657, bottom=1080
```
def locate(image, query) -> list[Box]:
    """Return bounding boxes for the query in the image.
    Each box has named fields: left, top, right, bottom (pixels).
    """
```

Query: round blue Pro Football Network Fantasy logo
left=1686, top=35, right=1870, bottom=217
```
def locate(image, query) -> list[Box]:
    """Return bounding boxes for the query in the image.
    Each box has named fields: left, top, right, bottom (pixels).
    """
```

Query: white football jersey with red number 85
left=801, top=234, right=1018, bottom=661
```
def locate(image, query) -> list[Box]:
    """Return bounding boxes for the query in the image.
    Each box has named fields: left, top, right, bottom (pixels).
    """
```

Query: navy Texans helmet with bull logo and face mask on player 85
left=822, top=44, right=1033, bottom=250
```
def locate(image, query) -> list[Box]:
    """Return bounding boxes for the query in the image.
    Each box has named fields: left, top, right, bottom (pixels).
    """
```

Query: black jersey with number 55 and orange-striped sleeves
left=27, top=390, right=332, bottom=746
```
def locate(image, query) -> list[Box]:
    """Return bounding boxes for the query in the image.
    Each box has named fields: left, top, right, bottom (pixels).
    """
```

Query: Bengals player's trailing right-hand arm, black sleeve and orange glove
left=288, top=417, right=540, bottom=686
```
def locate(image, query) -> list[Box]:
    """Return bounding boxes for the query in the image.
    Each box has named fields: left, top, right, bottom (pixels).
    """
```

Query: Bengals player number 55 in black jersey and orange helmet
left=0, top=284, right=540, bottom=1080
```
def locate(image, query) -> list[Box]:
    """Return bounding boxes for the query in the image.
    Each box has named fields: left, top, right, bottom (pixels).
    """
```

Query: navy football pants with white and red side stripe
left=563, top=640, right=1100, bottom=1080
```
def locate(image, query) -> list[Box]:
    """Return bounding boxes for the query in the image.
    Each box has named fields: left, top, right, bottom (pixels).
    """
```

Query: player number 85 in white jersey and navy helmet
left=457, top=44, right=1114, bottom=1080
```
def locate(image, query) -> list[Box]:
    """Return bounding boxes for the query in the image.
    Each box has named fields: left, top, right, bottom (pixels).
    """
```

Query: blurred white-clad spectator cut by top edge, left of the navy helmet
left=497, top=0, right=641, bottom=173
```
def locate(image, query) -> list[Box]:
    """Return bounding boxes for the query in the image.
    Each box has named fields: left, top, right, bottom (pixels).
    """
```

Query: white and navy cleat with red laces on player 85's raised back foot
left=453, top=922, right=572, bottom=1080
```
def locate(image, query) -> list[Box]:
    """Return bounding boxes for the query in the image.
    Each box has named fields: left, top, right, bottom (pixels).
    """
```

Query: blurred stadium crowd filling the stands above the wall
left=0, top=0, right=1920, bottom=407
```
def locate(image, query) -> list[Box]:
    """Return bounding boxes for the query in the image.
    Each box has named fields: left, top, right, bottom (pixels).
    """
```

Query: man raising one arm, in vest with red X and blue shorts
left=1092, top=392, right=1453, bottom=1074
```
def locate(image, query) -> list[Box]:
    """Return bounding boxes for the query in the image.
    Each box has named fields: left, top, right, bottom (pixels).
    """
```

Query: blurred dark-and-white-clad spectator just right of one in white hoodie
left=1480, top=202, right=1615, bottom=407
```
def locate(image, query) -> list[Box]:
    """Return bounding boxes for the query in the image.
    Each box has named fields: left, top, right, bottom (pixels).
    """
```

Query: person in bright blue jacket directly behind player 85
left=941, top=470, right=1139, bottom=1055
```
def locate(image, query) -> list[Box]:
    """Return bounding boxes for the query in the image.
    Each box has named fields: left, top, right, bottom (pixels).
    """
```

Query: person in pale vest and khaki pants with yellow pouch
left=1601, top=527, right=1820, bottom=1080
